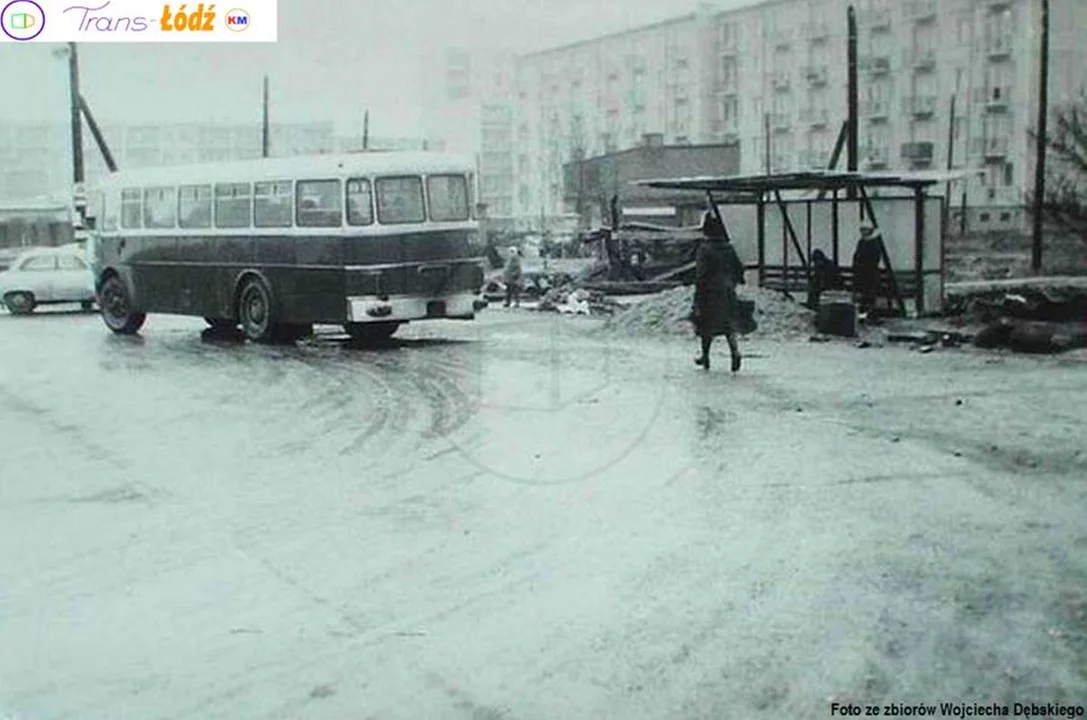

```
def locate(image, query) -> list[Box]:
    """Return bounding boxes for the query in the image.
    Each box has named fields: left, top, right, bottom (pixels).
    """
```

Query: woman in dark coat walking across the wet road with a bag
left=691, top=213, right=744, bottom=372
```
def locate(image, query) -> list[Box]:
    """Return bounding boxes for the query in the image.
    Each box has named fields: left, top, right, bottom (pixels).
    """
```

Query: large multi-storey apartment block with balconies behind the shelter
left=514, top=0, right=1087, bottom=224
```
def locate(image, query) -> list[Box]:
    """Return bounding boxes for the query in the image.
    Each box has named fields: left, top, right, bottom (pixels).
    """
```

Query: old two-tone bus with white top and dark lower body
left=91, top=152, right=484, bottom=342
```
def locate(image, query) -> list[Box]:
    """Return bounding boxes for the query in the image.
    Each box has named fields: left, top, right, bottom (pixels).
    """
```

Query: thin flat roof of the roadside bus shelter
left=633, top=171, right=970, bottom=193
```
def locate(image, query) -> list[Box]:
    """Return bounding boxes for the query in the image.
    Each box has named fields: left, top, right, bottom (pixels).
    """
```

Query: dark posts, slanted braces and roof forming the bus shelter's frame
left=634, top=171, right=965, bottom=314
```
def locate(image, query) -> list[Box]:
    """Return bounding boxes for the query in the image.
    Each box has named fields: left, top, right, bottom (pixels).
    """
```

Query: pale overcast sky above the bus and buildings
left=0, top=0, right=756, bottom=136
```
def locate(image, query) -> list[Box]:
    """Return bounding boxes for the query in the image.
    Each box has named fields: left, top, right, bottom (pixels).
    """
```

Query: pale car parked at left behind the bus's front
left=0, top=248, right=95, bottom=315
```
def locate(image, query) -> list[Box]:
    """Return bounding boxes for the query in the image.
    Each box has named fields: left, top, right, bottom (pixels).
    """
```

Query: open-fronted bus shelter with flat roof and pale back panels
left=635, top=171, right=962, bottom=315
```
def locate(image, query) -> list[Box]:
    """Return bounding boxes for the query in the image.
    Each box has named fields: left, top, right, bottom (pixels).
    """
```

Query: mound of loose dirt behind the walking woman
left=608, top=286, right=814, bottom=339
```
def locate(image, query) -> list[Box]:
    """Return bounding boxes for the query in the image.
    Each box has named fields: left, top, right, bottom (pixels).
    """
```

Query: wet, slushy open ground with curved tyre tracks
left=0, top=309, right=1087, bottom=720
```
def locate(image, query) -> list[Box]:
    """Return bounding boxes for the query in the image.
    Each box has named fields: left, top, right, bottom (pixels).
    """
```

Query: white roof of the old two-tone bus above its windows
left=96, top=152, right=475, bottom=187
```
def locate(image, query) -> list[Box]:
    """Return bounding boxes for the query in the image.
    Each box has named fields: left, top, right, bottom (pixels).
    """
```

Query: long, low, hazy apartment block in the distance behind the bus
left=0, top=123, right=336, bottom=202
